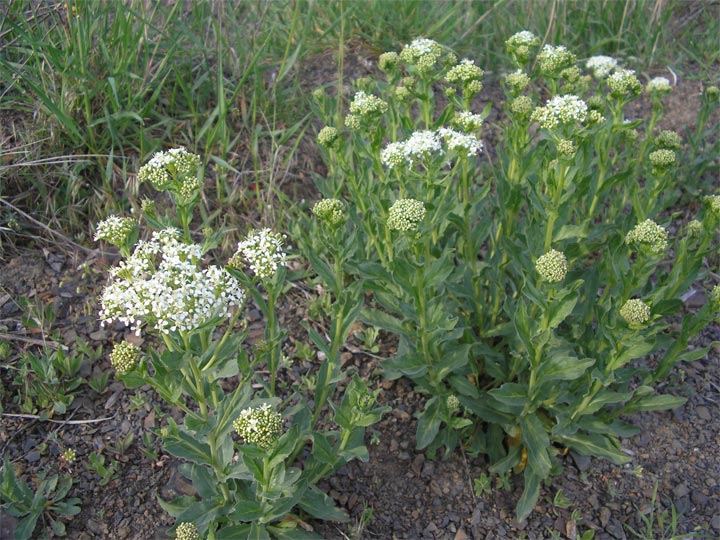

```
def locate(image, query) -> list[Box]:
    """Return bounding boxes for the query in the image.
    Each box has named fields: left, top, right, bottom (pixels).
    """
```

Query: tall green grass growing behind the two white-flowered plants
left=0, top=0, right=720, bottom=249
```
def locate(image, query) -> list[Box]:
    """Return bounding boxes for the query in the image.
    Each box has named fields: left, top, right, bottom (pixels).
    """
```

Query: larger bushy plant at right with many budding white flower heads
left=306, top=31, right=720, bottom=519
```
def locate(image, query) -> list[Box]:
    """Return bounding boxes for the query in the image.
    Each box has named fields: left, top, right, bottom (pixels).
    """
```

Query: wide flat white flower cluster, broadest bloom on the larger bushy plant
left=380, top=127, right=483, bottom=169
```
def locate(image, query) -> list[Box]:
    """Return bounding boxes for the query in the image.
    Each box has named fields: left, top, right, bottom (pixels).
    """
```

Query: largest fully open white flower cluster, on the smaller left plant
left=100, top=229, right=245, bottom=335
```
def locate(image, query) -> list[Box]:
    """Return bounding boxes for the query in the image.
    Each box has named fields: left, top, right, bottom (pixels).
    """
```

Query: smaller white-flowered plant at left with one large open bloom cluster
left=97, top=149, right=384, bottom=540
